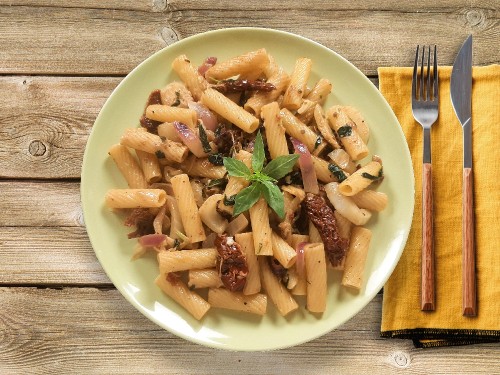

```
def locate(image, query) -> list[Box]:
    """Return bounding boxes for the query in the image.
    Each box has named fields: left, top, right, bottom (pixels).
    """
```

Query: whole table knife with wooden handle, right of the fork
left=450, top=35, right=477, bottom=316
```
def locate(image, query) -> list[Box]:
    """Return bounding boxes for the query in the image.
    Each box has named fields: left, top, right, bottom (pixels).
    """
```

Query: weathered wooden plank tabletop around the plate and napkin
left=0, top=0, right=500, bottom=375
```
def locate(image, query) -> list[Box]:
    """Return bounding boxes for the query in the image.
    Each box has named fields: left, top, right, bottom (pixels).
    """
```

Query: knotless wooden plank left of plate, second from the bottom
left=0, top=227, right=111, bottom=284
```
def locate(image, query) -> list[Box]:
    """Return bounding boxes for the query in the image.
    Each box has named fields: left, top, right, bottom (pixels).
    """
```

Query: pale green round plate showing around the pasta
left=81, top=28, right=414, bottom=351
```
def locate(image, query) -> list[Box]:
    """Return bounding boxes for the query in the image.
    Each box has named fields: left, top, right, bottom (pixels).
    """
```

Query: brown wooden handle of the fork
left=421, top=163, right=436, bottom=311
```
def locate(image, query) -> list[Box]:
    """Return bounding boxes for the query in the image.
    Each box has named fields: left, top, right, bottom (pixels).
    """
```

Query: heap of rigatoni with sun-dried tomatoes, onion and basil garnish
left=105, top=49, right=388, bottom=319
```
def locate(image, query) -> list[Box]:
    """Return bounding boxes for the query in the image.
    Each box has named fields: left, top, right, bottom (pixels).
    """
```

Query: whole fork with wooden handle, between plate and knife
left=411, top=46, right=439, bottom=311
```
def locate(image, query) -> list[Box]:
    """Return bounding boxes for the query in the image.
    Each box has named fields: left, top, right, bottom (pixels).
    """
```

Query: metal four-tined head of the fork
left=411, top=46, right=439, bottom=128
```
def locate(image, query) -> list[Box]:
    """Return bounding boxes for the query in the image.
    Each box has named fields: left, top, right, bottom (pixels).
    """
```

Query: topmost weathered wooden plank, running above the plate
left=0, top=5, right=500, bottom=75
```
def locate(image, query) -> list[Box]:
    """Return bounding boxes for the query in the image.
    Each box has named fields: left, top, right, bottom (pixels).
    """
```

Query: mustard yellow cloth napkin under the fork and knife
left=378, top=65, right=500, bottom=347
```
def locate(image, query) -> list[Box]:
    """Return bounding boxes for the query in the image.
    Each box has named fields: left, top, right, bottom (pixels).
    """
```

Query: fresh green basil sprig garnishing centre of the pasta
left=223, top=132, right=299, bottom=219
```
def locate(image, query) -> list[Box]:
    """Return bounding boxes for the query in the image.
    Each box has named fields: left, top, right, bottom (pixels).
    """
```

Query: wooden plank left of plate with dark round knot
left=0, top=76, right=121, bottom=179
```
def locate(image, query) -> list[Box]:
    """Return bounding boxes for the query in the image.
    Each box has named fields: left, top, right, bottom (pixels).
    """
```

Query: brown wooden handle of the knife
left=462, top=168, right=477, bottom=316
